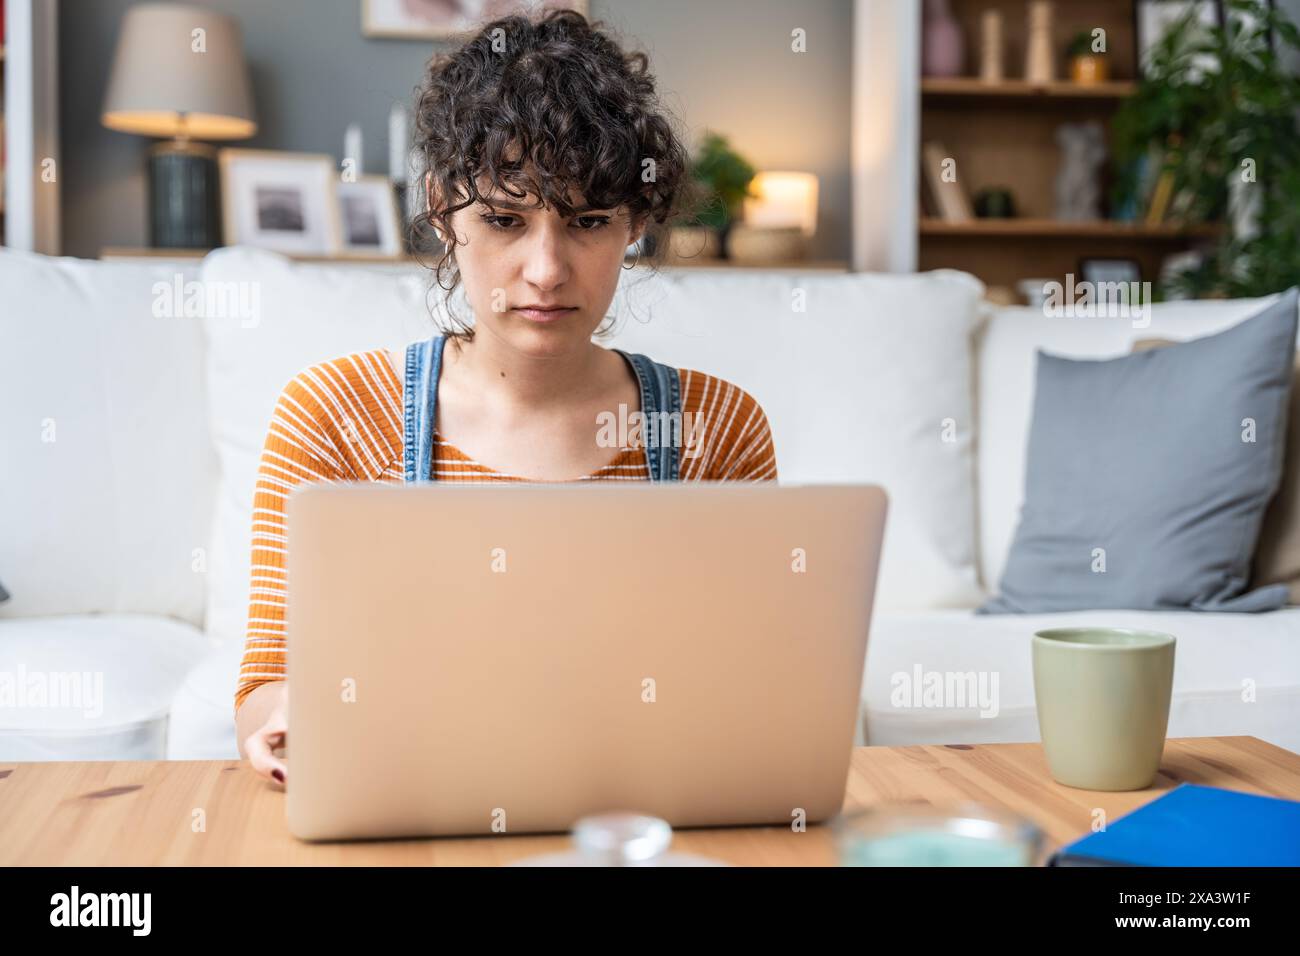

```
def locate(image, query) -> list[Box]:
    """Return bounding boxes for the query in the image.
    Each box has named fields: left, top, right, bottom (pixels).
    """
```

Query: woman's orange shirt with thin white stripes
left=235, top=350, right=776, bottom=710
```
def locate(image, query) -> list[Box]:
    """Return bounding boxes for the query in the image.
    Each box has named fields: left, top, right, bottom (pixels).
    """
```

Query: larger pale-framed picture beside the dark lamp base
left=217, top=147, right=339, bottom=256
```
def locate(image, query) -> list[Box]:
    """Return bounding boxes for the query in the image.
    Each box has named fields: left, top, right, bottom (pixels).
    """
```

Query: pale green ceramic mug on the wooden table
left=1034, top=627, right=1175, bottom=791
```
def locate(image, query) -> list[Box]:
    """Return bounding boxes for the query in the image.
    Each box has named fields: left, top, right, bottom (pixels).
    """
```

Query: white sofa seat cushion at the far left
left=0, top=614, right=209, bottom=761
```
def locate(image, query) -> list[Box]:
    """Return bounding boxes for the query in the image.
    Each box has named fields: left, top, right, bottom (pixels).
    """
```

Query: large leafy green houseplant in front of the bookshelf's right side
left=1113, top=0, right=1300, bottom=297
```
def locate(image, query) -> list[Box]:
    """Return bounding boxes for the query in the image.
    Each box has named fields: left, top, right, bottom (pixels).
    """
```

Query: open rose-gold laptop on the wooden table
left=286, top=483, right=885, bottom=840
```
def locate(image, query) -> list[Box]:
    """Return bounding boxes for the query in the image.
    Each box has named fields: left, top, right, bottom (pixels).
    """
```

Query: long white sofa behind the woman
left=0, top=250, right=1300, bottom=760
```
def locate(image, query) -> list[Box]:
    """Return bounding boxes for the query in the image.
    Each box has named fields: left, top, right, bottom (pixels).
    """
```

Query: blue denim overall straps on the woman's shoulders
left=402, top=336, right=681, bottom=484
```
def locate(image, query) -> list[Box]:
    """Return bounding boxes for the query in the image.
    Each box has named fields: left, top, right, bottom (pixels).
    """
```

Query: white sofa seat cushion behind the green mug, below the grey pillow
left=863, top=607, right=1300, bottom=753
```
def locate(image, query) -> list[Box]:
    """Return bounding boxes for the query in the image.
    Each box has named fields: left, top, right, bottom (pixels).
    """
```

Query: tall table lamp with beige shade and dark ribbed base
left=100, top=4, right=257, bottom=248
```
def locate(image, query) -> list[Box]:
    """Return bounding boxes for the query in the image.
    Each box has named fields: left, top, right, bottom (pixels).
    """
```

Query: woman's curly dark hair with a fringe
left=410, top=10, right=702, bottom=338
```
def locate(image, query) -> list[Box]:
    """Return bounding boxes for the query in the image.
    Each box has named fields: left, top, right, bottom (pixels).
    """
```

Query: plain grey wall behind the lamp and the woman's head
left=59, top=0, right=853, bottom=259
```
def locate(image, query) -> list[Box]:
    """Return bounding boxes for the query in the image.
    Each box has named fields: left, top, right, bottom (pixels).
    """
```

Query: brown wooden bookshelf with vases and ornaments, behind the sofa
left=917, top=0, right=1219, bottom=290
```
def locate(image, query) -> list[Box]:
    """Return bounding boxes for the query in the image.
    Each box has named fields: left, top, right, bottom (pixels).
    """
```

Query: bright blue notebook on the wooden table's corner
left=1048, top=783, right=1300, bottom=866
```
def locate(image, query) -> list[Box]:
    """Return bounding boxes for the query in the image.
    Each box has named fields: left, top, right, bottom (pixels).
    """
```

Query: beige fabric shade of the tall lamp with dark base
left=100, top=4, right=257, bottom=139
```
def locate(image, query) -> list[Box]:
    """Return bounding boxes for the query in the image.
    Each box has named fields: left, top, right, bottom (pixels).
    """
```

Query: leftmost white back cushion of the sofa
left=0, top=250, right=216, bottom=624
